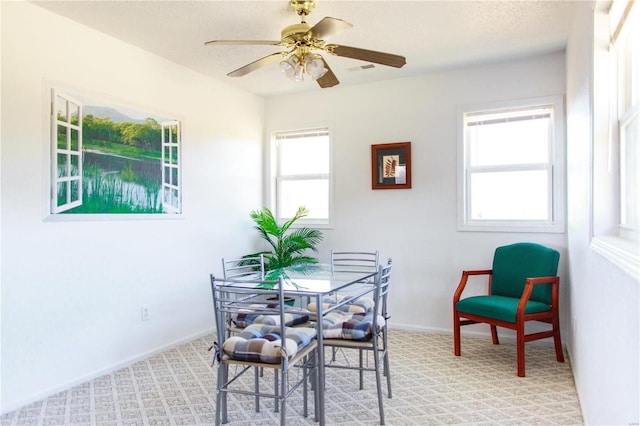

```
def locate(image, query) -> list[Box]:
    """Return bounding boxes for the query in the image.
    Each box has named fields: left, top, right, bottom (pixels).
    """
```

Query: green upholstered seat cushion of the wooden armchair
left=456, top=296, right=551, bottom=323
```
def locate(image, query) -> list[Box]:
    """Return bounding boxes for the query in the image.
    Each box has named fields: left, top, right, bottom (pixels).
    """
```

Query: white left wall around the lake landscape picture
left=0, top=2, right=264, bottom=412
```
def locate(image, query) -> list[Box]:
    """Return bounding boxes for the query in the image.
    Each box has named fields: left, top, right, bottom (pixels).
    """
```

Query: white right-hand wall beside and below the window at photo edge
left=565, top=2, right=640, bottom=424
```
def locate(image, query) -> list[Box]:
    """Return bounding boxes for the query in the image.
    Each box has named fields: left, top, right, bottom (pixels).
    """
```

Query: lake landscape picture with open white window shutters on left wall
left=50, top=88, right=182, bottom=215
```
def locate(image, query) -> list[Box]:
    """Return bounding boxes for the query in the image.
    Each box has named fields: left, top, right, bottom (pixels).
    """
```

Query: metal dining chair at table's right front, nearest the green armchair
left=323, top=259, right=392, bottom=425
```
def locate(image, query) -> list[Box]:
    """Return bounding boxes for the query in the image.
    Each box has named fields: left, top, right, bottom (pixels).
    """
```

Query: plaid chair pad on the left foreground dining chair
left=222, top=324, right=316, bottom=364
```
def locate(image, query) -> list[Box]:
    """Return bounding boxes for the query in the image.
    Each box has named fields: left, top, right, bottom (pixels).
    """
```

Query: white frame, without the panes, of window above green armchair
left=457, top=96, right=566, bottom=233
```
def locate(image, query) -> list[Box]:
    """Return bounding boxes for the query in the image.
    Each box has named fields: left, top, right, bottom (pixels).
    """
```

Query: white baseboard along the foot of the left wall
left=0, top=328, right=215, bottom=415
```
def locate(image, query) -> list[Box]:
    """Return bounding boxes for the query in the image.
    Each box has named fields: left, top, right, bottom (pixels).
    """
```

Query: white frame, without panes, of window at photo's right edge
left=590, top=0, right=640, bottom=279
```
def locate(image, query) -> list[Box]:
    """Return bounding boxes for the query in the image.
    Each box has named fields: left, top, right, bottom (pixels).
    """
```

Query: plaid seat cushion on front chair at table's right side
left=322, top=311, right=386, bottom=340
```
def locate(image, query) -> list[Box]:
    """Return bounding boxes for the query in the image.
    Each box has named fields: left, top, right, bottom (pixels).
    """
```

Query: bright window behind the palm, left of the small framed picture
left=272, top=128, right=332, bottom=225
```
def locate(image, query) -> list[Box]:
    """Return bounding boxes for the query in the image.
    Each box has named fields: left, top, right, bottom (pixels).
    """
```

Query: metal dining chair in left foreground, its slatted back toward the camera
left=210, top=275, right=317, bottom=425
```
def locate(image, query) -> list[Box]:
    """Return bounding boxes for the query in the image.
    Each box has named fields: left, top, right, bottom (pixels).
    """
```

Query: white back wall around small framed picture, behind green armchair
left=266, top=53, right=567, bottom=336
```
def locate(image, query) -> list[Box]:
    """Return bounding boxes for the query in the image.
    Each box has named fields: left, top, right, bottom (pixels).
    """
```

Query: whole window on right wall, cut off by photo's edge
left=591, top=0, right=640, bottom=278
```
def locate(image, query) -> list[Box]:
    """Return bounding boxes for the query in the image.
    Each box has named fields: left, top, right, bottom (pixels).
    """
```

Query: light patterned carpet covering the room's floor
left=1, top=330, right=583, bottom=426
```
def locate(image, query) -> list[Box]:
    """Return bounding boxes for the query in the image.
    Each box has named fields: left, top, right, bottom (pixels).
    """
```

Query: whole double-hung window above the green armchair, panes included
left=458, top=97, right=564, bottom=232
